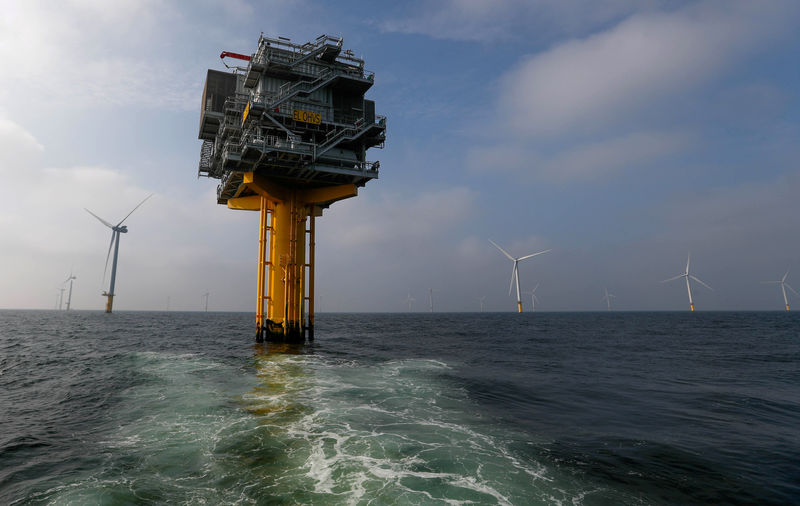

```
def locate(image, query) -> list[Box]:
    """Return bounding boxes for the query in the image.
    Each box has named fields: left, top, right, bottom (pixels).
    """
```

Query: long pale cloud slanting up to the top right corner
left=498, top=2, right=797, bottom=137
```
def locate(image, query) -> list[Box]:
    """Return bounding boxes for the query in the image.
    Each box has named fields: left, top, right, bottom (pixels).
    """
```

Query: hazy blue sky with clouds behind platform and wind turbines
left=0, top=0, right=800, bottom=312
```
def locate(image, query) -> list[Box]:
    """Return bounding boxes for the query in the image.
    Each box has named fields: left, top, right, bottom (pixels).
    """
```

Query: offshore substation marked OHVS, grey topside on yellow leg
left=198, top=34, right=386, bottom=342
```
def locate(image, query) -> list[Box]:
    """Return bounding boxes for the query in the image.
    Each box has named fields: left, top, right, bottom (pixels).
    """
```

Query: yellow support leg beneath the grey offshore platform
left=228, top=172, right=357, bottom=342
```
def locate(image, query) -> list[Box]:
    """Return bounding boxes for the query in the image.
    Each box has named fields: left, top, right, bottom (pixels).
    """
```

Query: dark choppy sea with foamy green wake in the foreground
left=0, top=311, right=800, bottom=505
